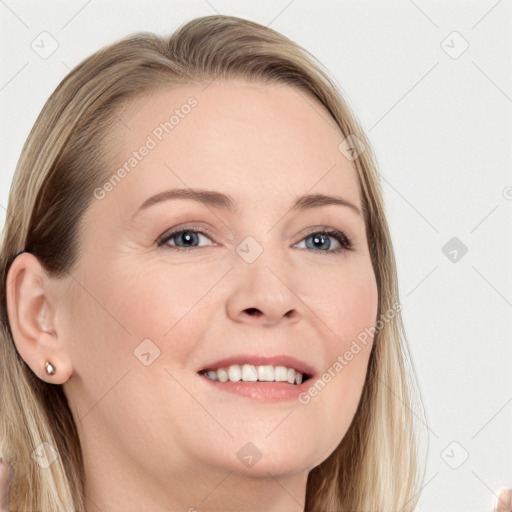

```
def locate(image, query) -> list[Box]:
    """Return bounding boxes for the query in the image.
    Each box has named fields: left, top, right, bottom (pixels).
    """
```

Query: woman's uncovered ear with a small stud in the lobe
left=6, top=252, right=72, bottom=384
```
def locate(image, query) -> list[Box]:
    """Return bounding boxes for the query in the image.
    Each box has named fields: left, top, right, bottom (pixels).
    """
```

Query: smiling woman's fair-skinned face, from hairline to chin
left=61, top=81, right=377, bottom=492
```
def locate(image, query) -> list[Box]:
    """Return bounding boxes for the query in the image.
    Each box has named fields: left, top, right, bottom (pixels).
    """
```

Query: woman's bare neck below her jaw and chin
left=84, top=436, right=308, bottom=512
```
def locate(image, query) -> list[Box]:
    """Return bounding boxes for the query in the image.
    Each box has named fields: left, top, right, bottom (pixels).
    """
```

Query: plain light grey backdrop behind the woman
left=0, top=0, right=512, bottom=512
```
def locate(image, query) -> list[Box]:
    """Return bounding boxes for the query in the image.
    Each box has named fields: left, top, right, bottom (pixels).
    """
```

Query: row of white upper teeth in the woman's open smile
left=205, top=364, right=303, bottom=384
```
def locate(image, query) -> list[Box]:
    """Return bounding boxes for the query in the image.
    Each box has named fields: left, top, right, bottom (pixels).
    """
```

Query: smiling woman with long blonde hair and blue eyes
left=0, top=16, right=423, bottom=512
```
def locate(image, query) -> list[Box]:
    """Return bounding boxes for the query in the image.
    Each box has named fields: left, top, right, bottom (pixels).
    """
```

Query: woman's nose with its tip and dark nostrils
left=226, top=252, right=303, bottom=327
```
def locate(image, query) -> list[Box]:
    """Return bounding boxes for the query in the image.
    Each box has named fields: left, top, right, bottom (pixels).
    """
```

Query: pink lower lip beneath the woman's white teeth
left=199, top=374, right=311, bottom=402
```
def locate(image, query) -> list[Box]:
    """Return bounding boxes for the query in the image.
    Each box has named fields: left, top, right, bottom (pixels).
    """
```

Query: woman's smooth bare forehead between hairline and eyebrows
left=102, top=80, right=361, bottom=214
